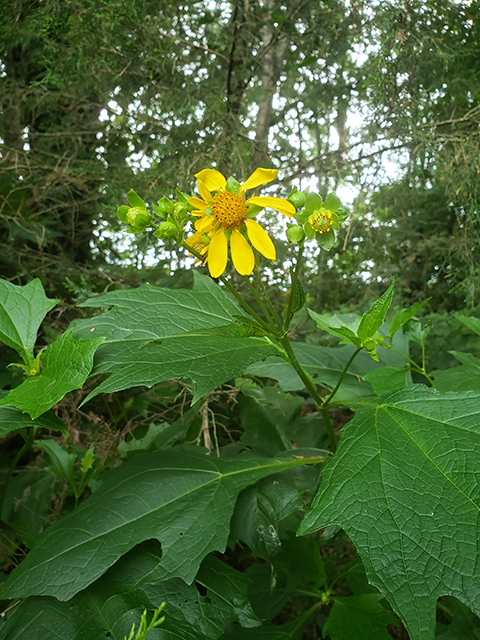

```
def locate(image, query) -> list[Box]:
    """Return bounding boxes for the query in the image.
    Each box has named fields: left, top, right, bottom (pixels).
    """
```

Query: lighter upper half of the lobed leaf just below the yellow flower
left=72, top=272, right=243, bottom=344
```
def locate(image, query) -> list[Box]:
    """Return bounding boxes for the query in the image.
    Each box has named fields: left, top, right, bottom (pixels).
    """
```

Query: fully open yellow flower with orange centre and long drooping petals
left=187, top=168, right=295, bottom=278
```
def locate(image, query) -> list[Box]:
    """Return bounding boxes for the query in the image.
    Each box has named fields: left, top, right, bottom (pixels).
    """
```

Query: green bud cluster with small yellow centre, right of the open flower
left=287, top=187, right=348, bottom=251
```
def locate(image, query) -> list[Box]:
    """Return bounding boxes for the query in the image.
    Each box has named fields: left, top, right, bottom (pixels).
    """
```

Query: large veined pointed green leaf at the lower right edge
left=299, top=385, right=480, bottom=640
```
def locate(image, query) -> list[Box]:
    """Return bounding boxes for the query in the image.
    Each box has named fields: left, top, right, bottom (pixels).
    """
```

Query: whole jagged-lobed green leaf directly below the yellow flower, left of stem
left=74, top=274, right=278, bottom=402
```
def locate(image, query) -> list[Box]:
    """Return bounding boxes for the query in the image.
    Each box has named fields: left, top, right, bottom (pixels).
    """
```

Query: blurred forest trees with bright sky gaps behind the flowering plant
left=0, top=0, right=480, bottom=638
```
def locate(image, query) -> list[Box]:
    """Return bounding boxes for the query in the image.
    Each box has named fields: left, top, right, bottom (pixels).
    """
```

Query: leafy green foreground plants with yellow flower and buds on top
left=0, top=168, right=480, bottom=640
